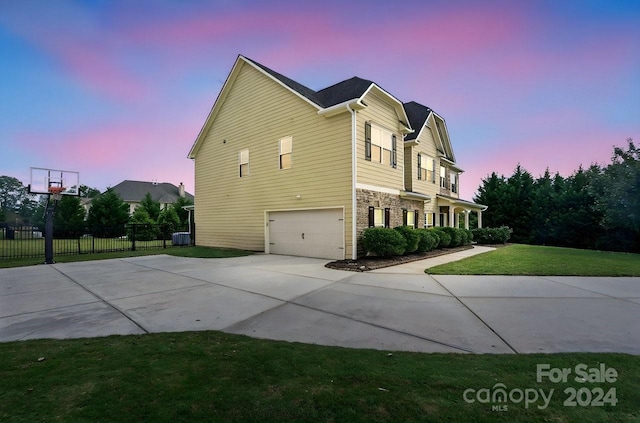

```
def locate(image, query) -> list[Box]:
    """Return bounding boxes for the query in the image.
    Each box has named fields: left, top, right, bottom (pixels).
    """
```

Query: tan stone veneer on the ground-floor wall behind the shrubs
left=356, top=189, right=424, bottom=256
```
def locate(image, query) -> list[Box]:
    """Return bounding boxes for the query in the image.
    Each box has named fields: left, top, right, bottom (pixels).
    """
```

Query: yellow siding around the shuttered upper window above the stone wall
left=356, top=93, right=404, bottom=190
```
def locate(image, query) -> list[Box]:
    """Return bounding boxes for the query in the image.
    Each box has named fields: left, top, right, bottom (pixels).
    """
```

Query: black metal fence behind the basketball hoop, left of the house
left=0, top=223, right=193, bottom=260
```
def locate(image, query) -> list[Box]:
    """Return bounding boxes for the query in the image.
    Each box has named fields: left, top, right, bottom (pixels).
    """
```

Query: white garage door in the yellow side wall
left=268, top=209, right=344, bottom=260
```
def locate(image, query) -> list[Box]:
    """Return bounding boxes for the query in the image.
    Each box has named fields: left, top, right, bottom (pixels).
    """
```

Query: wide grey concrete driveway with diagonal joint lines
left=0, top=255, right=640, bottom=354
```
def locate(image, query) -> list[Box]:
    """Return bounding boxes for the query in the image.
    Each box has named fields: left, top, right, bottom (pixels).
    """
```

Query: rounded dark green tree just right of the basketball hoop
left=87, top=188, right=129, bottom=238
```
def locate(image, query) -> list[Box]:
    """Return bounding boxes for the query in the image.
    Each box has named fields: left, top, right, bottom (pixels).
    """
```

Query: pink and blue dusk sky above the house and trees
left=0, top=0, right=640, bottom=199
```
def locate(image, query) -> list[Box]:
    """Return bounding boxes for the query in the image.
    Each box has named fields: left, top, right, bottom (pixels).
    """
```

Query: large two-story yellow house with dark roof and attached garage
left=189, top=56, right=486, bottom=259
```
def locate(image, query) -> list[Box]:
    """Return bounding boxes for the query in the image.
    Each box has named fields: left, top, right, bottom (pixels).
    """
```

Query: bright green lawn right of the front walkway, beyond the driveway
left=425, top=244, right=640, bottom=276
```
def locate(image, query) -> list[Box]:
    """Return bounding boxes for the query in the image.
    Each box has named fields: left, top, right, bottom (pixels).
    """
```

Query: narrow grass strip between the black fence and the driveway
left=0, top=246, right=252, bottom=268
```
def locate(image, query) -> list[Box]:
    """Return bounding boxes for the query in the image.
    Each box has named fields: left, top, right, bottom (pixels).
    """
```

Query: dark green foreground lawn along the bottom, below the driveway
left=0, top=332, right=640, bottom=422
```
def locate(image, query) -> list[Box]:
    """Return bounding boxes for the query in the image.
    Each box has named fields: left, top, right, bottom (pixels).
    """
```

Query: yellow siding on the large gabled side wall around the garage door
left=195, top=63, right=352, bottom=252
